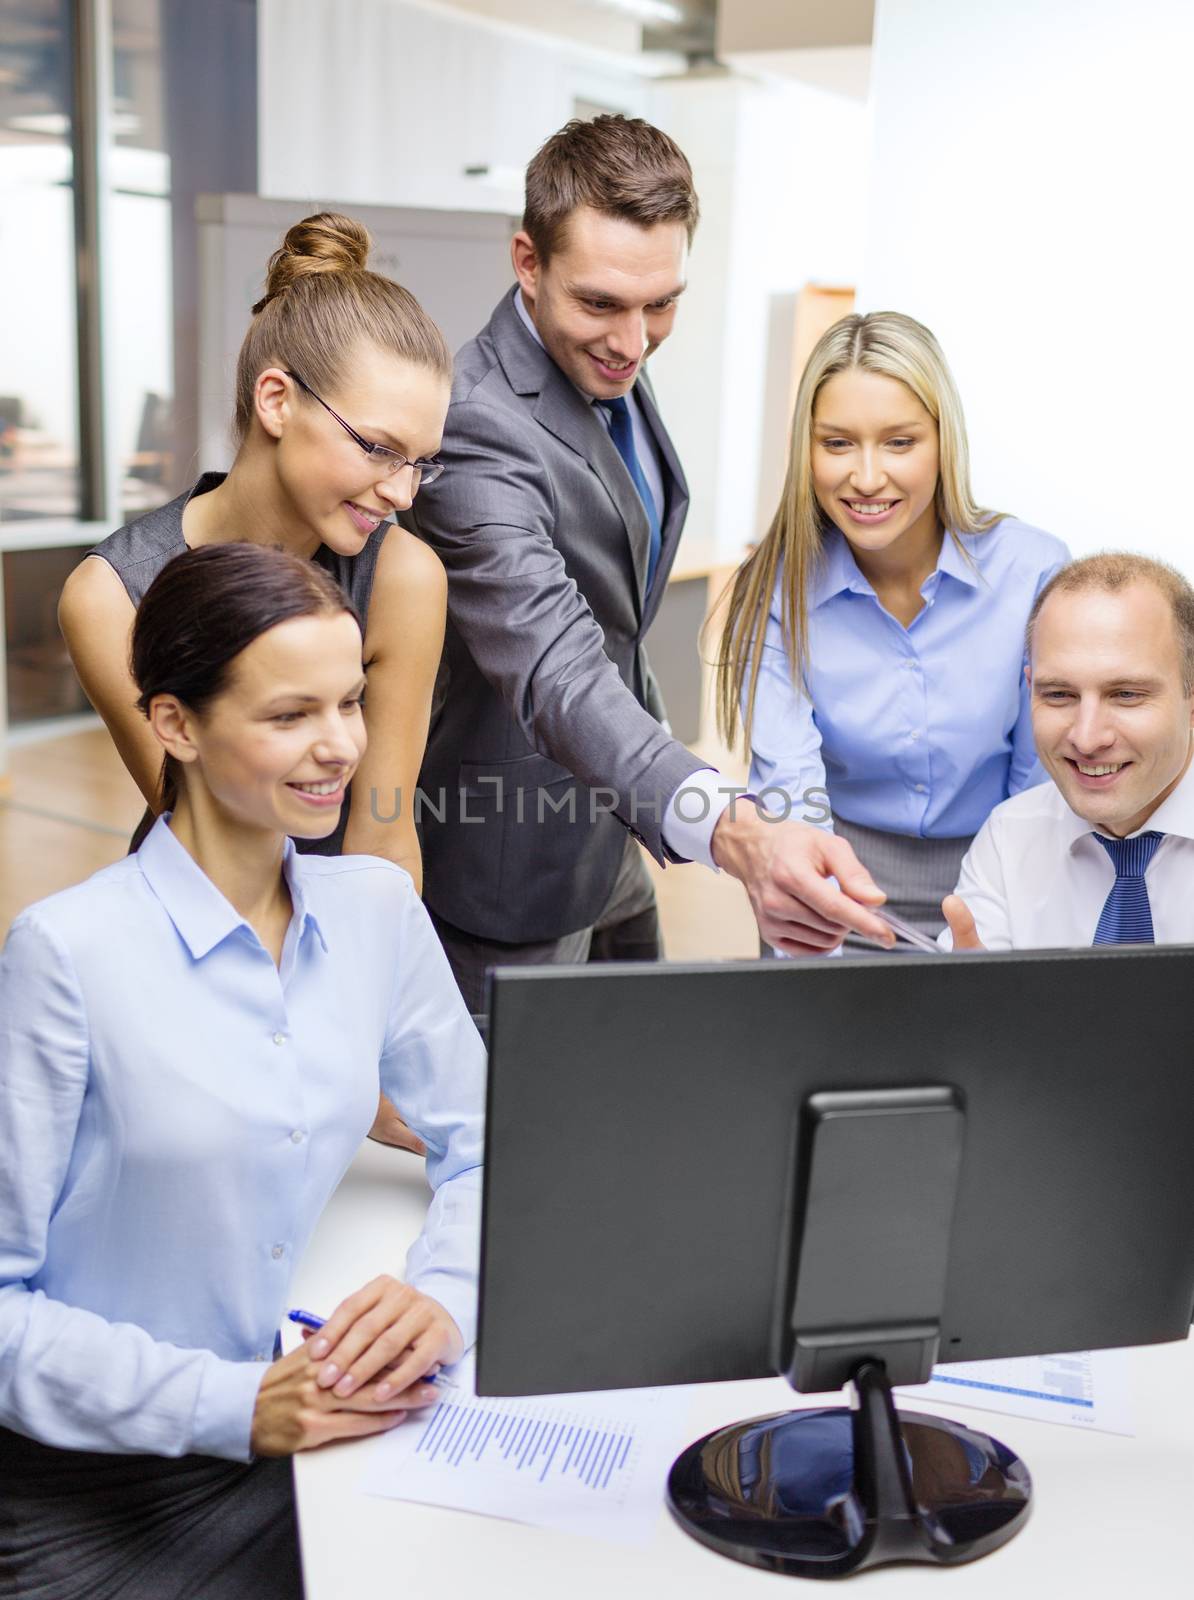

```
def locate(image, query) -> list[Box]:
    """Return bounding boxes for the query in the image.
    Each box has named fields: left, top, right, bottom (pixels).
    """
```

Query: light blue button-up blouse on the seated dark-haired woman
left=0, top=818, right=485, bottom=1461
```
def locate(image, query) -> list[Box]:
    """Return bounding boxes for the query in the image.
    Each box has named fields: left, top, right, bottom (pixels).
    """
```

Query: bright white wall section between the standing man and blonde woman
left=651, top=77, right=866, bottom=558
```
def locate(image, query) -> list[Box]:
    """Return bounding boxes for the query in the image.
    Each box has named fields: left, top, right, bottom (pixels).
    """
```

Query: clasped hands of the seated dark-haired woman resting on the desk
left=250, top=1277, right=464, bottom=1456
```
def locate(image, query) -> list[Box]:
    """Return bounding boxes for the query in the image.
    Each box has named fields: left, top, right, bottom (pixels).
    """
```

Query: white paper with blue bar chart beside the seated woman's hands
left=360, top=1362, right=691, bottom=1544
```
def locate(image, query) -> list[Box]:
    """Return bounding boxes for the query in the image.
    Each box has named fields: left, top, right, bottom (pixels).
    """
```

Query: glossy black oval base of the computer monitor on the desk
left=667, top=1362, right=1032, bottom=1578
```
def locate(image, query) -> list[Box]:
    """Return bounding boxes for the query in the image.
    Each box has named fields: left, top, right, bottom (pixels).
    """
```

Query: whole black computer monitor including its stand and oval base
left=477, top=946, right=1194, bottom=1576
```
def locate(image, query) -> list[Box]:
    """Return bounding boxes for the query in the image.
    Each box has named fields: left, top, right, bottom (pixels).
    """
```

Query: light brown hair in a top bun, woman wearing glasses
left=235, top=211, right=451, bottom=440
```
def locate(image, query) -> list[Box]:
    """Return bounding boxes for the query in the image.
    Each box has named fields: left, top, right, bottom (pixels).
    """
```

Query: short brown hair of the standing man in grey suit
left=522, top=115, right=701, bottom=262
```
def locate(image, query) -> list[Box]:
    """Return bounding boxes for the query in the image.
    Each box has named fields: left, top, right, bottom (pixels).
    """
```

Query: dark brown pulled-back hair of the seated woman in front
left=131, top=544, right=360, bottom=811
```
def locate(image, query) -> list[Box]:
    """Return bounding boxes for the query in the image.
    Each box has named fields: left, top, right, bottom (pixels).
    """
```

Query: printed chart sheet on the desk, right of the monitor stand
left=900, top=1350, right=1136, bottom=1435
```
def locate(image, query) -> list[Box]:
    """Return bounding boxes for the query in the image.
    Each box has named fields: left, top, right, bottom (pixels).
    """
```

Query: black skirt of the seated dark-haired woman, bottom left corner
left=0, top=1429, right=303, bottom=1600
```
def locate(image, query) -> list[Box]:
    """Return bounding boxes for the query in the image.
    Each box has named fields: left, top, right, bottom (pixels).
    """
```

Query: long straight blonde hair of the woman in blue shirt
left=717, top=310, right=1004, bottom=750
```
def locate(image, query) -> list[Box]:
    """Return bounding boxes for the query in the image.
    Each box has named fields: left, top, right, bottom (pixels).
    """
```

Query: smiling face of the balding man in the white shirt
left=1031, top=582, right=1194, bottom=838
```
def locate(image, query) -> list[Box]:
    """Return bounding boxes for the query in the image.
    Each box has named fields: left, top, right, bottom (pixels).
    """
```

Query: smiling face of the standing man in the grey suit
left=512, top=206, right=688, bottom=400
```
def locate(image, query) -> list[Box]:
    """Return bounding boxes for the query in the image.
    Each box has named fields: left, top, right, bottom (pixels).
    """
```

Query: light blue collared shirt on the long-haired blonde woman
left=751, top=517, right=1069, bottom=838
